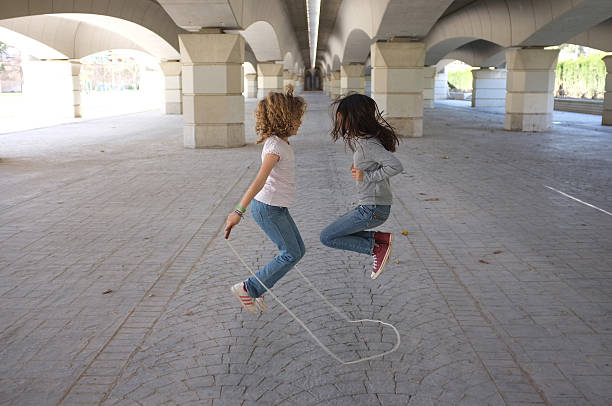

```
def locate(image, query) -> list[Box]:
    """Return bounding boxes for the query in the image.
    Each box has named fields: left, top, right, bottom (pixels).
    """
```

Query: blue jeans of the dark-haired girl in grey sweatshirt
left=321, top=205, right=391, bottom=255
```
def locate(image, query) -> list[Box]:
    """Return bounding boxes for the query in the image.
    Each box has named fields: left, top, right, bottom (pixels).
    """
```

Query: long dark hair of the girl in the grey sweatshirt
left=330, top=93, right=399, bottom=152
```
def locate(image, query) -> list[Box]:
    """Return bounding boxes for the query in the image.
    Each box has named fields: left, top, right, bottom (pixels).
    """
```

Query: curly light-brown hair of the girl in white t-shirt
left=255, top=85, right=306, bottom=144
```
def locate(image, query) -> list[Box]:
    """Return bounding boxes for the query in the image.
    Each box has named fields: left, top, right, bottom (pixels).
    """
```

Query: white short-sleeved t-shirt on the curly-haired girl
left=255, top=135, right=295, bottom=207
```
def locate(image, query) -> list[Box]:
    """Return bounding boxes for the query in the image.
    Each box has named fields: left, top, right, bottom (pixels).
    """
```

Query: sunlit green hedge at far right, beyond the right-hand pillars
left=555, top=53, right=606, bottom=99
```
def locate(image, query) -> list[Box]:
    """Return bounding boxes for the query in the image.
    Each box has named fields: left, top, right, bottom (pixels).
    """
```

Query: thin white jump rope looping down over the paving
left=225, top=235, right=400, bottom=365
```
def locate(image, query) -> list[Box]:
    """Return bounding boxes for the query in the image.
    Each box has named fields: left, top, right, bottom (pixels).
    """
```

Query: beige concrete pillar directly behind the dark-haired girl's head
left=370, top=41, right=425, bottom=137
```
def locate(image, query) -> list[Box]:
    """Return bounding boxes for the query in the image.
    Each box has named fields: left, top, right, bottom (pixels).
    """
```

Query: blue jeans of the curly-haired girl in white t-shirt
left=244, top=199, right=306, bottom=297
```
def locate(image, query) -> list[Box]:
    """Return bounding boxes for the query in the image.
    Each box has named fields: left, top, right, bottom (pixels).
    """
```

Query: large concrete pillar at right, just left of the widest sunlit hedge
left=504, top=48, right=559, bottom=131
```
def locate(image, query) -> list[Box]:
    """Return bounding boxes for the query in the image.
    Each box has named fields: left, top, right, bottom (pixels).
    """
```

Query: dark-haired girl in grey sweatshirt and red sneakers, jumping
left=321, top=94, right=403, bottom=279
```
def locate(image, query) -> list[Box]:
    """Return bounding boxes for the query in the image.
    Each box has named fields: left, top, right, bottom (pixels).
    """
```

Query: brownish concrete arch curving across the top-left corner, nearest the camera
left=0, top=0, right=183, bottom=50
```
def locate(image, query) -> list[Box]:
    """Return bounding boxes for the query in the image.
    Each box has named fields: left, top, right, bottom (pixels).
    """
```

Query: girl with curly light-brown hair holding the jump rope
left=225, top=86, right=306, bottom=314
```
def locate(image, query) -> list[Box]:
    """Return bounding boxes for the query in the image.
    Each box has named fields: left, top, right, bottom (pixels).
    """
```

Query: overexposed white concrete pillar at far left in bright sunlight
left=22, top=59, right=81, bottom=118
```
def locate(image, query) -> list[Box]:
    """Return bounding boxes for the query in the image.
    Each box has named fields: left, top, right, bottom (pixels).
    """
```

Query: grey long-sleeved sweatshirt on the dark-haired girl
left=353, top=138, right=403, bottom=205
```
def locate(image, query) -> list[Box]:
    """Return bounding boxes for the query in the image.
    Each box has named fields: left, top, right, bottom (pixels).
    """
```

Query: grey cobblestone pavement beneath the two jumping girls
left=0, top=94, right=612, bottom=406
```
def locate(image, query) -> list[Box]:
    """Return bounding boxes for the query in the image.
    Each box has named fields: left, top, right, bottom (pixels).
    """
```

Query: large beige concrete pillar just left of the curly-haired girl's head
left=179, top=31, right=245, bottom=148
